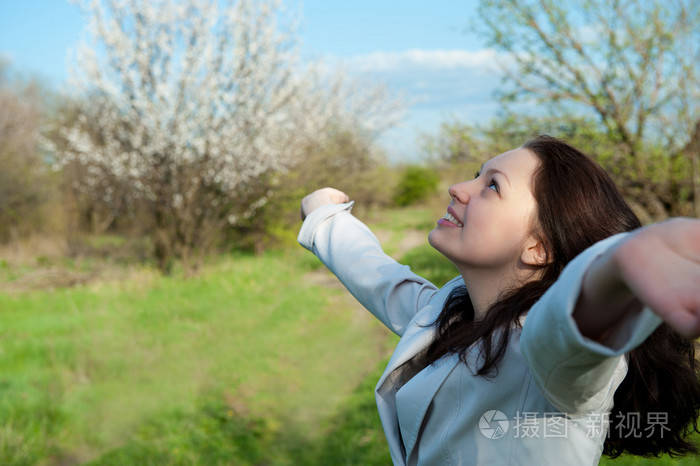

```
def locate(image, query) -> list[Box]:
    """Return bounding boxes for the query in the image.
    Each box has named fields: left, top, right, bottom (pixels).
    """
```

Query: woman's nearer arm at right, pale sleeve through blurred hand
left=520, top=219, right=700, bottom=414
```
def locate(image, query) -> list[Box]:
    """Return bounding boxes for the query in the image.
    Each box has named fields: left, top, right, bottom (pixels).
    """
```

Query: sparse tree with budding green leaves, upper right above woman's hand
left=479, top=0, right=700, bottom=217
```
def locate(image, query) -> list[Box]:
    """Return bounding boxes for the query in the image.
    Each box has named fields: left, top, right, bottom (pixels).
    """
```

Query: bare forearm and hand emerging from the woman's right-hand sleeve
left=573, top=218, right=700, bottom=343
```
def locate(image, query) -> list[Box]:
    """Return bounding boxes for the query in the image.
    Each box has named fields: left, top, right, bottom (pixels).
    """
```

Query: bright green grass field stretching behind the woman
left=0, top=209, right=697, bottom=466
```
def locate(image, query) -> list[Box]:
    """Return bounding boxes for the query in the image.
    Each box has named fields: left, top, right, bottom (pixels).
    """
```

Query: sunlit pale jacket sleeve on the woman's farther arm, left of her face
left=298, top=202, right=437, bottom=336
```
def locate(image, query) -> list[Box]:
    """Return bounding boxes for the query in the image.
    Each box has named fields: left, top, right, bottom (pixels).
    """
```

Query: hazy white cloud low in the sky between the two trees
left=324, top=49, right=506, bottom=161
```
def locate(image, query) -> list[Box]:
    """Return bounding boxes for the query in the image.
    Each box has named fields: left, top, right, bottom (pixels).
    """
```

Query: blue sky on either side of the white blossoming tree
left=0, top=0, right=500, bottom=160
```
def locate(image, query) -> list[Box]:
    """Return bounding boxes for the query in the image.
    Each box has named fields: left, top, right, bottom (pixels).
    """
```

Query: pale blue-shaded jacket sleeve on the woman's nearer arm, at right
left=520, top=234, right=661, bottom=415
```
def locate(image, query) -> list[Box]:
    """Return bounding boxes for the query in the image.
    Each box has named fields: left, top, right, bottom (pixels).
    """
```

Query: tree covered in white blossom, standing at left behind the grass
left=59, top=0, right=398, bottom=271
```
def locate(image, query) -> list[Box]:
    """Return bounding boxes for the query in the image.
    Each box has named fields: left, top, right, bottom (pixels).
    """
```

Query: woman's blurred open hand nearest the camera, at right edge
left=613, top=218, right=700, bottom=338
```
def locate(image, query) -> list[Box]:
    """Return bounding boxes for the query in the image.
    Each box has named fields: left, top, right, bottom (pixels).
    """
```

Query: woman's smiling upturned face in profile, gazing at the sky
left=428, top=148, right=539, bottom=273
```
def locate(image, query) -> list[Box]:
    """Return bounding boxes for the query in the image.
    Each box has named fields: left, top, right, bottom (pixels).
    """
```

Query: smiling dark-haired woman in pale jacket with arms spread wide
left=299, top=136, right=700, bottom=465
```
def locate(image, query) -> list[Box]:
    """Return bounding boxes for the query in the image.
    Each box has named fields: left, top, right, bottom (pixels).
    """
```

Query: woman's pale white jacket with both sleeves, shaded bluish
left=298, top=203, right=663, bottom=466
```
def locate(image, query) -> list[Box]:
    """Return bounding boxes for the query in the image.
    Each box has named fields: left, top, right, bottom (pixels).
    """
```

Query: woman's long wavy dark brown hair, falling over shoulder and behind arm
left=427, top=136, right=700, bottom=458
